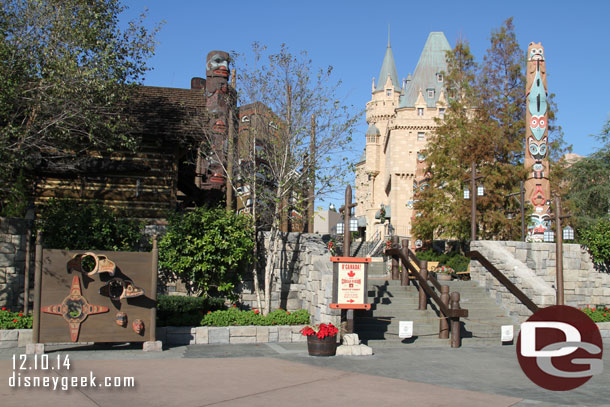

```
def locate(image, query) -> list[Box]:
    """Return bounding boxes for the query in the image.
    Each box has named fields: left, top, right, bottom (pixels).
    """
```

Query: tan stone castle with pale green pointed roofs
left=356, top=32, right=451, bottom=240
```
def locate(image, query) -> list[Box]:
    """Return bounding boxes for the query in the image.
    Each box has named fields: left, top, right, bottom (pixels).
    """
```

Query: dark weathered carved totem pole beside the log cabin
left=200, top=51, right=231, bottom=189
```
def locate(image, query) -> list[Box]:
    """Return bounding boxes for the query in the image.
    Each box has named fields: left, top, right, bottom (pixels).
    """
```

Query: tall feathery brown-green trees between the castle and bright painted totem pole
left=415, top=18, right=525, bottom=240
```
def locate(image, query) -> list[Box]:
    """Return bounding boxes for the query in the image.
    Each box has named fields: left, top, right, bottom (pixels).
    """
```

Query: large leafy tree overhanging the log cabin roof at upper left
left=0, top=0, right=156, bottom=215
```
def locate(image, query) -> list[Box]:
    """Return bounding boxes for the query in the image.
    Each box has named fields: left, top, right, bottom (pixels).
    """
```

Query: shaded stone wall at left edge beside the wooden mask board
left=0, top=218, right=35, bottom=310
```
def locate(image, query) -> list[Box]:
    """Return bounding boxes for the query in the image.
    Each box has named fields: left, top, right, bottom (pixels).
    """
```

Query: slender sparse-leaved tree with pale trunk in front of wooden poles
left=230, top=43, right=361, bottom=314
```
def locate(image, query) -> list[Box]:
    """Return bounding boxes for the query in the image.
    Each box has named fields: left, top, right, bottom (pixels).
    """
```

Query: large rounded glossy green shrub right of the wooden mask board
left=159, top=207, right=254, bottom=300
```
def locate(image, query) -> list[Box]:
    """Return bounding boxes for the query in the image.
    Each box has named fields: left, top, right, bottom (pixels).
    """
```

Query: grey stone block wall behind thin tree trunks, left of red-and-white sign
left=241, top=233, right=340, bottom=326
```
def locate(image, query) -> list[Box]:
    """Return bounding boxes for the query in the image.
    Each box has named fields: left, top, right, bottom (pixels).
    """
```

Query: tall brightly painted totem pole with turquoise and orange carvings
left=525, top=42, right=551, bottom=242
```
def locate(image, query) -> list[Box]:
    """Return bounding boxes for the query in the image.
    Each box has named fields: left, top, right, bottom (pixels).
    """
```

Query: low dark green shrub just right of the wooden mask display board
left=157, top=295, right=225, bottom=326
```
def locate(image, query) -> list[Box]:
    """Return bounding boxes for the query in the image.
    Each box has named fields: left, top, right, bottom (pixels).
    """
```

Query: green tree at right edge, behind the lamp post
left=566, top=120, right=610, bottom=232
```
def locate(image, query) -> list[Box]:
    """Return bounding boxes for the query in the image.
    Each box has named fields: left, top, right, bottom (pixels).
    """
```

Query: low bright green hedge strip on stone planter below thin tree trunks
left=201, top=306, right=310, bottom=326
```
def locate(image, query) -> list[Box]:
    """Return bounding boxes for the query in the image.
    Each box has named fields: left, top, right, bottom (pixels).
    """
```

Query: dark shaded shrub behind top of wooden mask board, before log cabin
left=38, top=200, right=142, bottom=251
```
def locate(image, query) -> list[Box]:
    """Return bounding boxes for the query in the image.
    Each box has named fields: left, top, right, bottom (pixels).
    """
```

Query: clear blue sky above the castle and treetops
left=122, top=0, right=610, bottom=207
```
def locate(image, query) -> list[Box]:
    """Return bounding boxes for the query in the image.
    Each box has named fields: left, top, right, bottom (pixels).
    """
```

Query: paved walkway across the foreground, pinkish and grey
left=0, top=342, right=610, bottom=407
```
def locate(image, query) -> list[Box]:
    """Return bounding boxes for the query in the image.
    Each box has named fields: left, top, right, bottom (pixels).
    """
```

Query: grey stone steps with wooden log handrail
left=355, top=274, right=517, bottom=349
